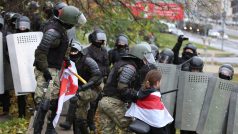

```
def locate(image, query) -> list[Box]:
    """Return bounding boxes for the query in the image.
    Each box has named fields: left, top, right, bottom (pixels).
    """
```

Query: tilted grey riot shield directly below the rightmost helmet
left=197, top=78, right=234, bottom=134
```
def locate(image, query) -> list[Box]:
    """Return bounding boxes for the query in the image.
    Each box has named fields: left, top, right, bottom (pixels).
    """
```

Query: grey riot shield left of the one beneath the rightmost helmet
left=175, top=71, right=210, bottom=131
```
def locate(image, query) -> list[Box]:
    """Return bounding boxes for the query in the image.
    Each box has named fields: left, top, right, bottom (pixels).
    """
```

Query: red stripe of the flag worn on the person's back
left=136, top=94, right=164, bottom=110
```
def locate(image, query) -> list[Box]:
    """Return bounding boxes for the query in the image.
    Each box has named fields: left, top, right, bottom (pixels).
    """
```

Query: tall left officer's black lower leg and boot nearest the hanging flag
left=45, top=100, right=58, bottom=134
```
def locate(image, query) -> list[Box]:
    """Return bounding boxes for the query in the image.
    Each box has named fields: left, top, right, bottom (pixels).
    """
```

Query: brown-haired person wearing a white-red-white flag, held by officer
left=125, top=70, right=173, bottom=134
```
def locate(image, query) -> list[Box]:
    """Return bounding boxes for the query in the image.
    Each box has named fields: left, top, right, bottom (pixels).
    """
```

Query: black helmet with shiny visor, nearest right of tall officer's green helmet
left=89, top=29, right=107, bottom=43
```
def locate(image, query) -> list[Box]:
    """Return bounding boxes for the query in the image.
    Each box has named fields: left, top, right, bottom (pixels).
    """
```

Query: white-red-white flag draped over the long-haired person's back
left=125, top=91, right=173, bottom=128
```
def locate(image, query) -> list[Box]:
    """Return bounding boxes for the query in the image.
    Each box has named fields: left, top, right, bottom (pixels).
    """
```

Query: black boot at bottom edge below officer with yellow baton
left=73, top=119, right=89, bottom=134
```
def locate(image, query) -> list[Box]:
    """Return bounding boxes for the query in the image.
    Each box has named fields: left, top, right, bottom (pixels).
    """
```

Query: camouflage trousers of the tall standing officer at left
left=34, top=68, right=60, bottom=104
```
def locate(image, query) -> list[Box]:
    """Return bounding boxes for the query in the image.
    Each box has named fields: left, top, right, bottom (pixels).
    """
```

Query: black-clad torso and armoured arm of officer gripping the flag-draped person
left=103, top=59, right=139, bottom=102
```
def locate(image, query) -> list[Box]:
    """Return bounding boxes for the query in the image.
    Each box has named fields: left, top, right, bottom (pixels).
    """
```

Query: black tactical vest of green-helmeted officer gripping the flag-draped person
left=103, top=60, right=137, bottom=98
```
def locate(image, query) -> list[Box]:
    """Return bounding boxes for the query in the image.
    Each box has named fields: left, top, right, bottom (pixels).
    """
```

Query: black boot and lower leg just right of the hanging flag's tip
left=59, top=99, right=77, bottom=130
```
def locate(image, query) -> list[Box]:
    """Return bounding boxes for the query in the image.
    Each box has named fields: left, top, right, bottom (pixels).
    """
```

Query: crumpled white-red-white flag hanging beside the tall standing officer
left=53, top=61, right=78, bottom=127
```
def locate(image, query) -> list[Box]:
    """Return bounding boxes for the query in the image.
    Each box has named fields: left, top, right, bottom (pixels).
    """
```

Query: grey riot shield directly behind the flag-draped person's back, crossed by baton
left=157, top=63, right=179, bottom=115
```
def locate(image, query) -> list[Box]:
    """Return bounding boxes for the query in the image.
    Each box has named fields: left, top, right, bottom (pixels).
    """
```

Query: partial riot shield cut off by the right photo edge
left=226, top=85, right=238, bottom=134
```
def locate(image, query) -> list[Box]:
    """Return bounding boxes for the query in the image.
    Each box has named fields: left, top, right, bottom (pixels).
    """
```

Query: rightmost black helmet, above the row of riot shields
left=219, top=64, right=234, bottom=80
